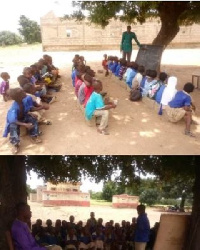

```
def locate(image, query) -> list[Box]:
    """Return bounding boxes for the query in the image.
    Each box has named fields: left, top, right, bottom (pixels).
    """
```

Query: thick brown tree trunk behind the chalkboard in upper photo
left=152, top=1, right=188, bottom=47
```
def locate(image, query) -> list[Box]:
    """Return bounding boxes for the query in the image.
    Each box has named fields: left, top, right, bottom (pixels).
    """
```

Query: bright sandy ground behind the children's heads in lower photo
left=29, top=202, right=161, bottom=229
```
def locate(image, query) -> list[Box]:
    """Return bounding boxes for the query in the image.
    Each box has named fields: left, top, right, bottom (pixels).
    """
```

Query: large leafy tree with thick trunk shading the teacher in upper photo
left=69, top=1, right=200, bottom=46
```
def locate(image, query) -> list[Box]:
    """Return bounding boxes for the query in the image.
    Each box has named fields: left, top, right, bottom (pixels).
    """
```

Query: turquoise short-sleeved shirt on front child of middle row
left=85, top=92, right=104, bottom=120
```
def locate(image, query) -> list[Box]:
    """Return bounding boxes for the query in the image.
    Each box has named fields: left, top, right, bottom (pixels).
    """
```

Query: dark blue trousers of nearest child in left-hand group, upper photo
left=10, top=115, right=39, bottom=145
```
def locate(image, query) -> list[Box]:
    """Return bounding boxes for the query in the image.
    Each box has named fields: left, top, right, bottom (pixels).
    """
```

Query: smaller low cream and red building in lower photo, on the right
left=112, top=194, right=139, bottom=208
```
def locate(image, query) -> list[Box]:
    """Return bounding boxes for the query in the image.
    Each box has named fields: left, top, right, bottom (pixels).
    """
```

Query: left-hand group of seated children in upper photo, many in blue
left=0, top=55, right=61, bottom=154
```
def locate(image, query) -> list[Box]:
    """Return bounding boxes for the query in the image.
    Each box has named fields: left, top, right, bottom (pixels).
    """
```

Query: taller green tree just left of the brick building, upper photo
left=19, top=15, right=41, bottom=44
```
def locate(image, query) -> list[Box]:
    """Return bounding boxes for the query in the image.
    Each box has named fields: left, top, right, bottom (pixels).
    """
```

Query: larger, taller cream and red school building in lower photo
left=30, top=182, right=90, bottom=207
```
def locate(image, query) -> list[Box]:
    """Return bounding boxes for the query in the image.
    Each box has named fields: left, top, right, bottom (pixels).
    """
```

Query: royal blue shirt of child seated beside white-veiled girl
left=168, top=91, right=192, bottom=108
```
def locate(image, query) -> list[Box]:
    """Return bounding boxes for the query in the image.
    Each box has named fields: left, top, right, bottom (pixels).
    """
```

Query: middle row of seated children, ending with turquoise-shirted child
left=71, top=55, right=117, bottom=135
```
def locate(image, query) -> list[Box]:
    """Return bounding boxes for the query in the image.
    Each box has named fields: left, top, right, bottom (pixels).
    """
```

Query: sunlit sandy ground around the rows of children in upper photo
left=0, top=45, right=200, bottom=155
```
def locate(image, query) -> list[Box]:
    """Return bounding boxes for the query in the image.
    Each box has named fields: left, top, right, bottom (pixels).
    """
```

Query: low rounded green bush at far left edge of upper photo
left=0, top=30, right=22, bottom=46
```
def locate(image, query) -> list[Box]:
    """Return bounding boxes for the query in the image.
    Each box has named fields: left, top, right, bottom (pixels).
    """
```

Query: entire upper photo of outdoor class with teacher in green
left=0, top=0, right=200, bottom=155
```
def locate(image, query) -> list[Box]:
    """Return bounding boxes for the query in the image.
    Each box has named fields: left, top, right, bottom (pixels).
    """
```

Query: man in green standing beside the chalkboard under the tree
left=120, top=26, right=141, bottom=62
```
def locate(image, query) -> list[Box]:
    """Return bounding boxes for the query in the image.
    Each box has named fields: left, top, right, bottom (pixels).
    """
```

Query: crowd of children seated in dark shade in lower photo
left=32, top=212, right=159, bottom=250
